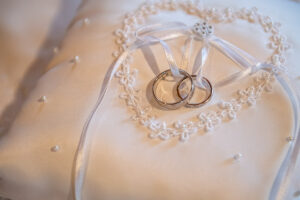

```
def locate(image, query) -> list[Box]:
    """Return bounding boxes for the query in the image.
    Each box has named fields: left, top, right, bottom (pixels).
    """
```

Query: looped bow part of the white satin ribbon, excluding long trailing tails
left=137, top=22, right=274, bottom=87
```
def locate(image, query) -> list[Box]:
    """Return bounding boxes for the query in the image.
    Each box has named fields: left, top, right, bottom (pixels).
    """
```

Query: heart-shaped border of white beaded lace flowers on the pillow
left=113, top=0, right=290, bottom=141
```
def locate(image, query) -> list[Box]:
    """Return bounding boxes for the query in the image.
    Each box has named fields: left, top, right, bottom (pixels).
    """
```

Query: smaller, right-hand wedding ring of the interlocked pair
left=177, top=75, right=213, bottom=108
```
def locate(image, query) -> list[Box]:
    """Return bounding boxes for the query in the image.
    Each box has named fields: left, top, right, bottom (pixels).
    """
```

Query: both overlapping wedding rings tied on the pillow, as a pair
left=152, top=69, right=213, bottom=110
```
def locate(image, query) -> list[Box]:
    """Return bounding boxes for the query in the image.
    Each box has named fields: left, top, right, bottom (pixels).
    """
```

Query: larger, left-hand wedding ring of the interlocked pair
left=152, top=69, right=194, bottom=110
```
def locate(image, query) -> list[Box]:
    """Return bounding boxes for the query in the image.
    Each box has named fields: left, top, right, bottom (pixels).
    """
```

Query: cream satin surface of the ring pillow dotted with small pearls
left=0, top=0, right=300, bottom=200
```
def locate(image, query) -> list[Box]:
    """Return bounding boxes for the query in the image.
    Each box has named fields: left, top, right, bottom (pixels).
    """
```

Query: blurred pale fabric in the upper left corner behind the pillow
left=0, top=0, right=80, bottom=135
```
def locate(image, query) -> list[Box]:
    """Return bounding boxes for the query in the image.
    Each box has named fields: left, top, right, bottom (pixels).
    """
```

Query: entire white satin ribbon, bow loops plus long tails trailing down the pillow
left=72, top=22, right=300, bottom=200
